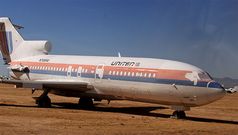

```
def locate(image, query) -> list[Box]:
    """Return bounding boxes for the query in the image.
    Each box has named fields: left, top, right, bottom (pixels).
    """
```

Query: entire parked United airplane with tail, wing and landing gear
left=0, top=17, right=226, bottom=119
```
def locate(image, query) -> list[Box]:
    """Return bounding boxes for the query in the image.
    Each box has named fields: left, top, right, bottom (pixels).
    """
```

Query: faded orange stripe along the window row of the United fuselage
left=10, top=61, right=192, bottom=80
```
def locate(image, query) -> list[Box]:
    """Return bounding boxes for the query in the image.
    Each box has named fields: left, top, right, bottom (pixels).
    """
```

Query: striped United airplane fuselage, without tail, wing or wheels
left=10, top=55, right=225, bottom=107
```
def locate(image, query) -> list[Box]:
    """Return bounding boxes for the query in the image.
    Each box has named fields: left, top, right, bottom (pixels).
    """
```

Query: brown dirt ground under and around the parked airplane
left=0, top=84, right=238, bottom=135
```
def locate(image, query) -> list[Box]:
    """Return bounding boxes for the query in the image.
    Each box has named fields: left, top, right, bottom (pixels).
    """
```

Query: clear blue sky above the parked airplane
left=0, top=0, right=238, bottom=78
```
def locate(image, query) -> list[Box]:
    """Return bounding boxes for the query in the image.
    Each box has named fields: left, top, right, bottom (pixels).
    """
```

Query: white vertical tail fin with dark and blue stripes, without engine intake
left=0, top=17, right=24, bottom=64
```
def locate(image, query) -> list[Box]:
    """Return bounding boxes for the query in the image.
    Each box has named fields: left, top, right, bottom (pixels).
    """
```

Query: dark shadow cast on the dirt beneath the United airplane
left=0, top=103, right=238, bottom=125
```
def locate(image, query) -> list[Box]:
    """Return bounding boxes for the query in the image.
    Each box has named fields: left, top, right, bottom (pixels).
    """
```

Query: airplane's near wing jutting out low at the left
left=2, top=80, right=94, bottom=92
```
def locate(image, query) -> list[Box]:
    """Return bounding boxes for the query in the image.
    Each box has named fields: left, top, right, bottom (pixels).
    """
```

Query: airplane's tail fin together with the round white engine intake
left=0, top=17, right=51, bottom=64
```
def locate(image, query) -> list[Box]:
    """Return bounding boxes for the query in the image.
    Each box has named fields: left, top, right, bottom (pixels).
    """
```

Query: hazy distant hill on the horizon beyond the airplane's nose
left=214, top=77, right=238, bottom=88
